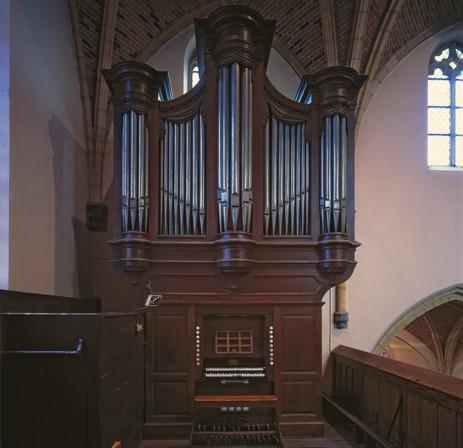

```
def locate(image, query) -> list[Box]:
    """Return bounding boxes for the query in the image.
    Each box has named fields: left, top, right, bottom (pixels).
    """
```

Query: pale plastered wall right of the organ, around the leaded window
left=324, top=31, right=463, bottom=351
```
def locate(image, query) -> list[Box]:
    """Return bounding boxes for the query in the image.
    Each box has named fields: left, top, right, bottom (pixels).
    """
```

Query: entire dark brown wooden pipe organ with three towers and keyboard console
left=105, top=6, right=364, bottom=446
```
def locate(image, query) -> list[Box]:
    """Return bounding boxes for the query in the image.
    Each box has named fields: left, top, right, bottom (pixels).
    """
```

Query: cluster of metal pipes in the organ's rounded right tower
left=320, top=114, right=347, bottom=233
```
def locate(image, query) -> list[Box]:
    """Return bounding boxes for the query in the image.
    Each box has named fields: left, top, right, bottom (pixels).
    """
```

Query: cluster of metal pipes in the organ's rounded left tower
left=121, top=110, right=149, bottom=232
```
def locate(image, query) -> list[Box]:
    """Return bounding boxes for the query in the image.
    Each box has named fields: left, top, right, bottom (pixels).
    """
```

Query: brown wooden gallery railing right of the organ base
left=323, top=346, right=463, bottom=448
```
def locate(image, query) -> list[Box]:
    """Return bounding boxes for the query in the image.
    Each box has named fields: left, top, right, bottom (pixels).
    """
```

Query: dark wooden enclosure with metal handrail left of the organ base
left=0, top=291, right=145, bottom=448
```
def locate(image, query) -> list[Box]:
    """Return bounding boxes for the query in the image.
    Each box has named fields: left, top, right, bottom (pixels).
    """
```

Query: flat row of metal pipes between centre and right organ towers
left=264, top=116, right=310, bottom=236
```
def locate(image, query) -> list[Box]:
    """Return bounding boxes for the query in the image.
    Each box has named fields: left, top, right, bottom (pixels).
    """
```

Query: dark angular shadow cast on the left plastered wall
left=48, top=114, right=91, bottom=297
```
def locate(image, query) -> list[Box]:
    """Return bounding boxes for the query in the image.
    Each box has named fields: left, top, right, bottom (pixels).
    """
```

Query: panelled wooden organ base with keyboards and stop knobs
left=145, top=301, right=323, bottom=440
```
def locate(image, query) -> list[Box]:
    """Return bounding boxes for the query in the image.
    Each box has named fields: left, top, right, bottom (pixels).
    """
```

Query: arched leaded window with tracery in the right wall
left=428, top=42, right=463, bottom=168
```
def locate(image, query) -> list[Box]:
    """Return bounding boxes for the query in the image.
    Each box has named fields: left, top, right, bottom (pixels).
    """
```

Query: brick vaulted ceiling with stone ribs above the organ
left=69, top=0, right=463, bottom=202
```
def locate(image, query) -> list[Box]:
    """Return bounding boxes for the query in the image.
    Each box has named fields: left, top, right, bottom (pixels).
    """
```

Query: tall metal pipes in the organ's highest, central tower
left=217, top=63, right=252, bottom=232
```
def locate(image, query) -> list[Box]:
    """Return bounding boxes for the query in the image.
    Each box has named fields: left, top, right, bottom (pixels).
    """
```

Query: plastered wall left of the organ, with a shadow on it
left=9, top=0, right=87, bottom=295
